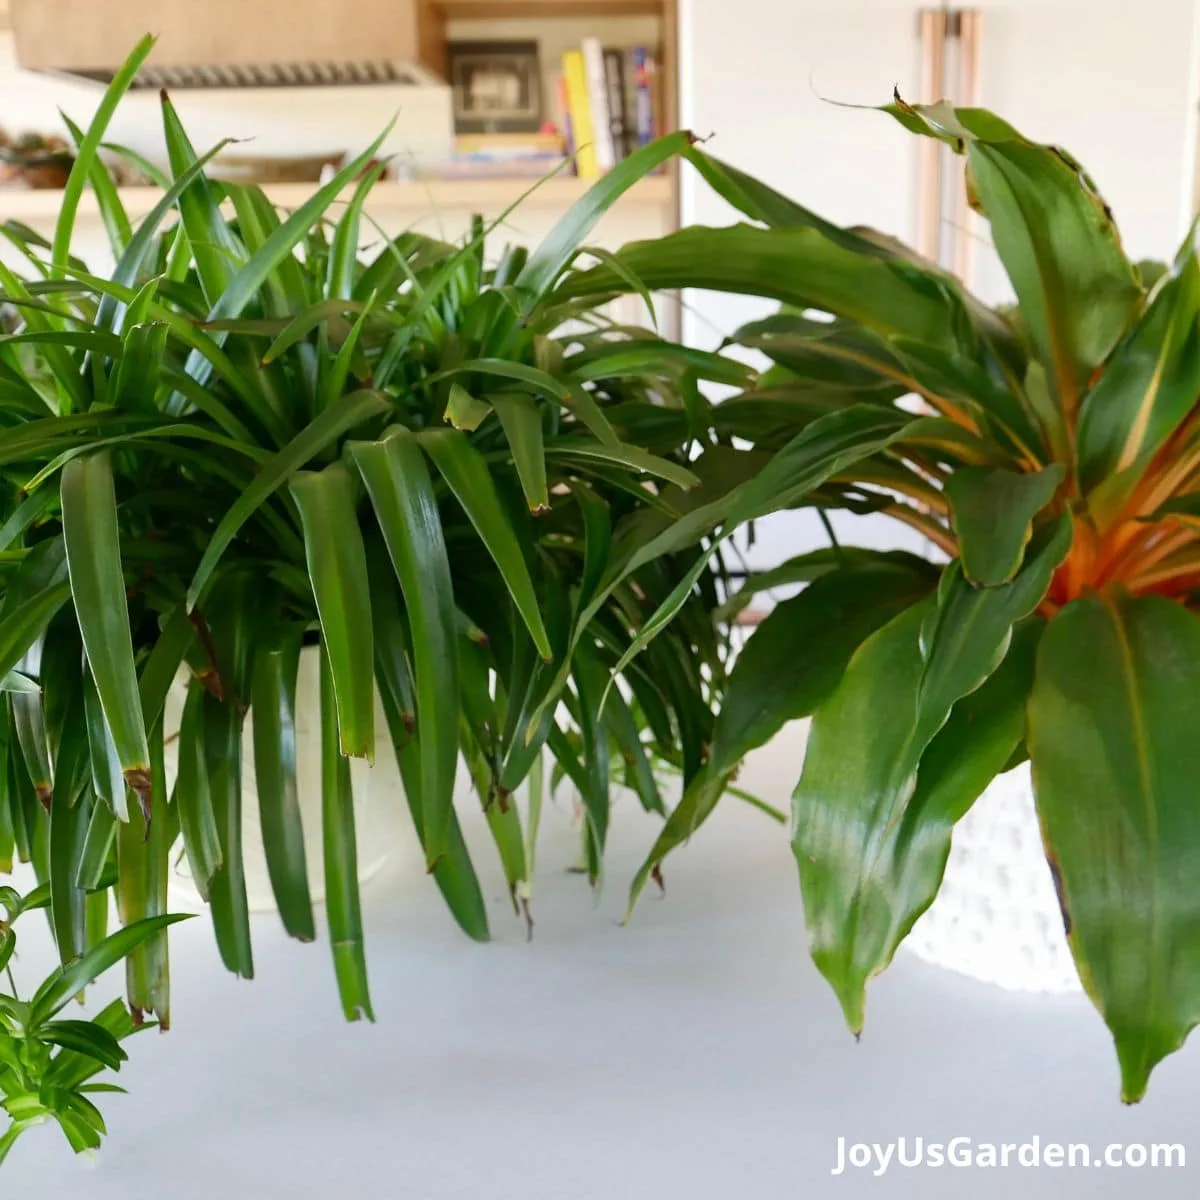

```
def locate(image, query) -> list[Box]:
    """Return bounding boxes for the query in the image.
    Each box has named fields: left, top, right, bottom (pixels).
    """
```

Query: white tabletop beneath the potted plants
left=0, top=731, right=1200, bottom=1200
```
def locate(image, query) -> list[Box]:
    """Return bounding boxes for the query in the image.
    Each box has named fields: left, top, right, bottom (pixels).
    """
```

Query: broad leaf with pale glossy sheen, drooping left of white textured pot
left=792, top=520, right=1070, bottom=1032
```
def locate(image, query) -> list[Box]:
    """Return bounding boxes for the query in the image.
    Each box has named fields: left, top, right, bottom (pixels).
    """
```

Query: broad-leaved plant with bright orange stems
left=563, top=97, right=1200, bottom=1103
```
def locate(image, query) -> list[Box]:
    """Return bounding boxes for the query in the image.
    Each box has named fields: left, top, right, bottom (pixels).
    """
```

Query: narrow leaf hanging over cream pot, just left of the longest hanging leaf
left=251, top=634, right=317, bottom=942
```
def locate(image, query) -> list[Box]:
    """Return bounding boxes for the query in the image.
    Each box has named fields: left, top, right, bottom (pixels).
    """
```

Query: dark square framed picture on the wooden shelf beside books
left=446, top=41, right=542, bottom=133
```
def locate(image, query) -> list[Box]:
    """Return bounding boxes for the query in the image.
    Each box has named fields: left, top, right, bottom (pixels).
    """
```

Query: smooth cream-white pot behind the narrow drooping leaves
left=164, top=646, right=412, bottom=912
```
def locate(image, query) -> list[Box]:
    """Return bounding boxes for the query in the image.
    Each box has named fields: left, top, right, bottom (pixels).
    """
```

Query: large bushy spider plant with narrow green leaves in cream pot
left=0, top=40, right=756, bottom=1041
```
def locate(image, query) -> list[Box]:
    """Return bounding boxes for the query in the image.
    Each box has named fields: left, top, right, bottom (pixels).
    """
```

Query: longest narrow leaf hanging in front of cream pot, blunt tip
left=320, top=650, right=374, bottom=1021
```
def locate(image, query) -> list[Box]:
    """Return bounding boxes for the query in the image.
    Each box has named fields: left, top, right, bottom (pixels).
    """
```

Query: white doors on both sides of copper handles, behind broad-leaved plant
left=680, top=0, right=1200, bottom=563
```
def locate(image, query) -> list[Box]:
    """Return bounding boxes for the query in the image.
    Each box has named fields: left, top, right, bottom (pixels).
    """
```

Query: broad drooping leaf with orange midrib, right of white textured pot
left=1028, top=590, right=1200, bottom=1103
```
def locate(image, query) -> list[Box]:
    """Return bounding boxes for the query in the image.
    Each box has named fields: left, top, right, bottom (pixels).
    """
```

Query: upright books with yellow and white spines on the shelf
left=558, top=37, right=665, bottom=179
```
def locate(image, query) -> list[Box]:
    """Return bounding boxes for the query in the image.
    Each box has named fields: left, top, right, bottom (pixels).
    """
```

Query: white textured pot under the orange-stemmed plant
left=904, top=762, right=1081, bottom=995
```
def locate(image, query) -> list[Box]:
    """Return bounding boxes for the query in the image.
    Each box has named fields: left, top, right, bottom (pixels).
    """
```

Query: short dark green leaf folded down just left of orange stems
left=946, top=463, right=1067, bottom=587
